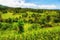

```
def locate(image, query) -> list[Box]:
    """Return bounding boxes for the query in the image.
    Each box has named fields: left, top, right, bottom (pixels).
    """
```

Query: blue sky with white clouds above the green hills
left=0, top=0, right=60, bottom=9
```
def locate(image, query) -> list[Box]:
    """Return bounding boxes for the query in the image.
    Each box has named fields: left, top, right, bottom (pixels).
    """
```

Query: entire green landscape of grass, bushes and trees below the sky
left=0, top=6, right=60, bottom=40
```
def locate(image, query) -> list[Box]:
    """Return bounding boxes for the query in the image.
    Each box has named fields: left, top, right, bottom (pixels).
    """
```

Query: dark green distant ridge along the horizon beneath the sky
left=0, top=5, right=60, bottom=13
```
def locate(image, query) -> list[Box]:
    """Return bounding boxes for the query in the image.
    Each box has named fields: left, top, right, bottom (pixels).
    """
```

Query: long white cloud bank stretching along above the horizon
left=0, top=0, right=56, bottom=9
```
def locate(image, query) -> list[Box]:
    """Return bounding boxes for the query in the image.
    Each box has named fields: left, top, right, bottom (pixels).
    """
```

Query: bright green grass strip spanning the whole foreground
left=0, top=27, right=60, bottom=40
